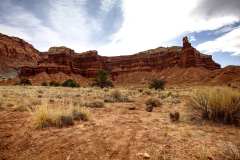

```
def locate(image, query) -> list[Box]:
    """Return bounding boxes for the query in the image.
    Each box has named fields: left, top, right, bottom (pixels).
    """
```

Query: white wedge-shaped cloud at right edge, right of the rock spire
left=197, top=27, right=240, bottom=55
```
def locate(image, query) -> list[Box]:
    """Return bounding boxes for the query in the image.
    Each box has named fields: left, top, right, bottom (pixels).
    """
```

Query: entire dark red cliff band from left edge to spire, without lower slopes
left=0, top=34, right=220, bottom=80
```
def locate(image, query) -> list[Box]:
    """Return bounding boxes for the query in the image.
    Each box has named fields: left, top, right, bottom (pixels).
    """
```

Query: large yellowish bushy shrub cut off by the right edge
left=189, top=87, right=240, bottom=125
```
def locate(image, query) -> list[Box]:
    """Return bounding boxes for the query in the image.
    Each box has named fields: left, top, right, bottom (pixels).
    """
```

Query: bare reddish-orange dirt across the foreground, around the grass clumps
left=0, top=88, right=240, bottom=160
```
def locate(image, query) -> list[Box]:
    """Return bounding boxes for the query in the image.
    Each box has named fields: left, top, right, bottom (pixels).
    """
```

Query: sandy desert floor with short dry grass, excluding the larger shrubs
left=0, top=86, right=240, bottom=160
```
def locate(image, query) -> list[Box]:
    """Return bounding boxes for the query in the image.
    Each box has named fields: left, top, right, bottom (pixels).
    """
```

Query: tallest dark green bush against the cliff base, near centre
left=92, top=70, right=113, bottom=88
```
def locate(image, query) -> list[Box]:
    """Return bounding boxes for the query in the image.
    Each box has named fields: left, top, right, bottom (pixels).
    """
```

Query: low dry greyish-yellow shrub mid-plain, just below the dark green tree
left=104, top=90, right=130, bottom=103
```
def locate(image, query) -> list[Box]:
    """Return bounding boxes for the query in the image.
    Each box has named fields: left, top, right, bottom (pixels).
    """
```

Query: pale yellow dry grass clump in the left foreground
left=33, top=104, right=90, bottom=128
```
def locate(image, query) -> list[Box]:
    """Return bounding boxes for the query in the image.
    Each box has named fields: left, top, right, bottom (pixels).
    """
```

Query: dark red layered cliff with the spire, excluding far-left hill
left=21, top=37, right=220, bottom=79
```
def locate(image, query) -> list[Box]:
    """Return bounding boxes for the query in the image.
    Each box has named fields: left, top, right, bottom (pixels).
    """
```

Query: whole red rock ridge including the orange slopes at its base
left=0, top=31, right=240, bottom=84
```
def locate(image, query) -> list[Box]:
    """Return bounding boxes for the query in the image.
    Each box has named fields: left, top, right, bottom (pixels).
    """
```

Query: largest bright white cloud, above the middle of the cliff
left=98, top=0, right=238, bottom=55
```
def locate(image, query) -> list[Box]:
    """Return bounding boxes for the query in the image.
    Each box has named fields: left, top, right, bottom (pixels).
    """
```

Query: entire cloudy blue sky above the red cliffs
left=0, top=0, right=240, bottom=66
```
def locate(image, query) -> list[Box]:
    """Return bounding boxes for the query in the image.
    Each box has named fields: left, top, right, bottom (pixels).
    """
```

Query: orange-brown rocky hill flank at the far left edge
left=0, top=33, right=40, bottom=73
